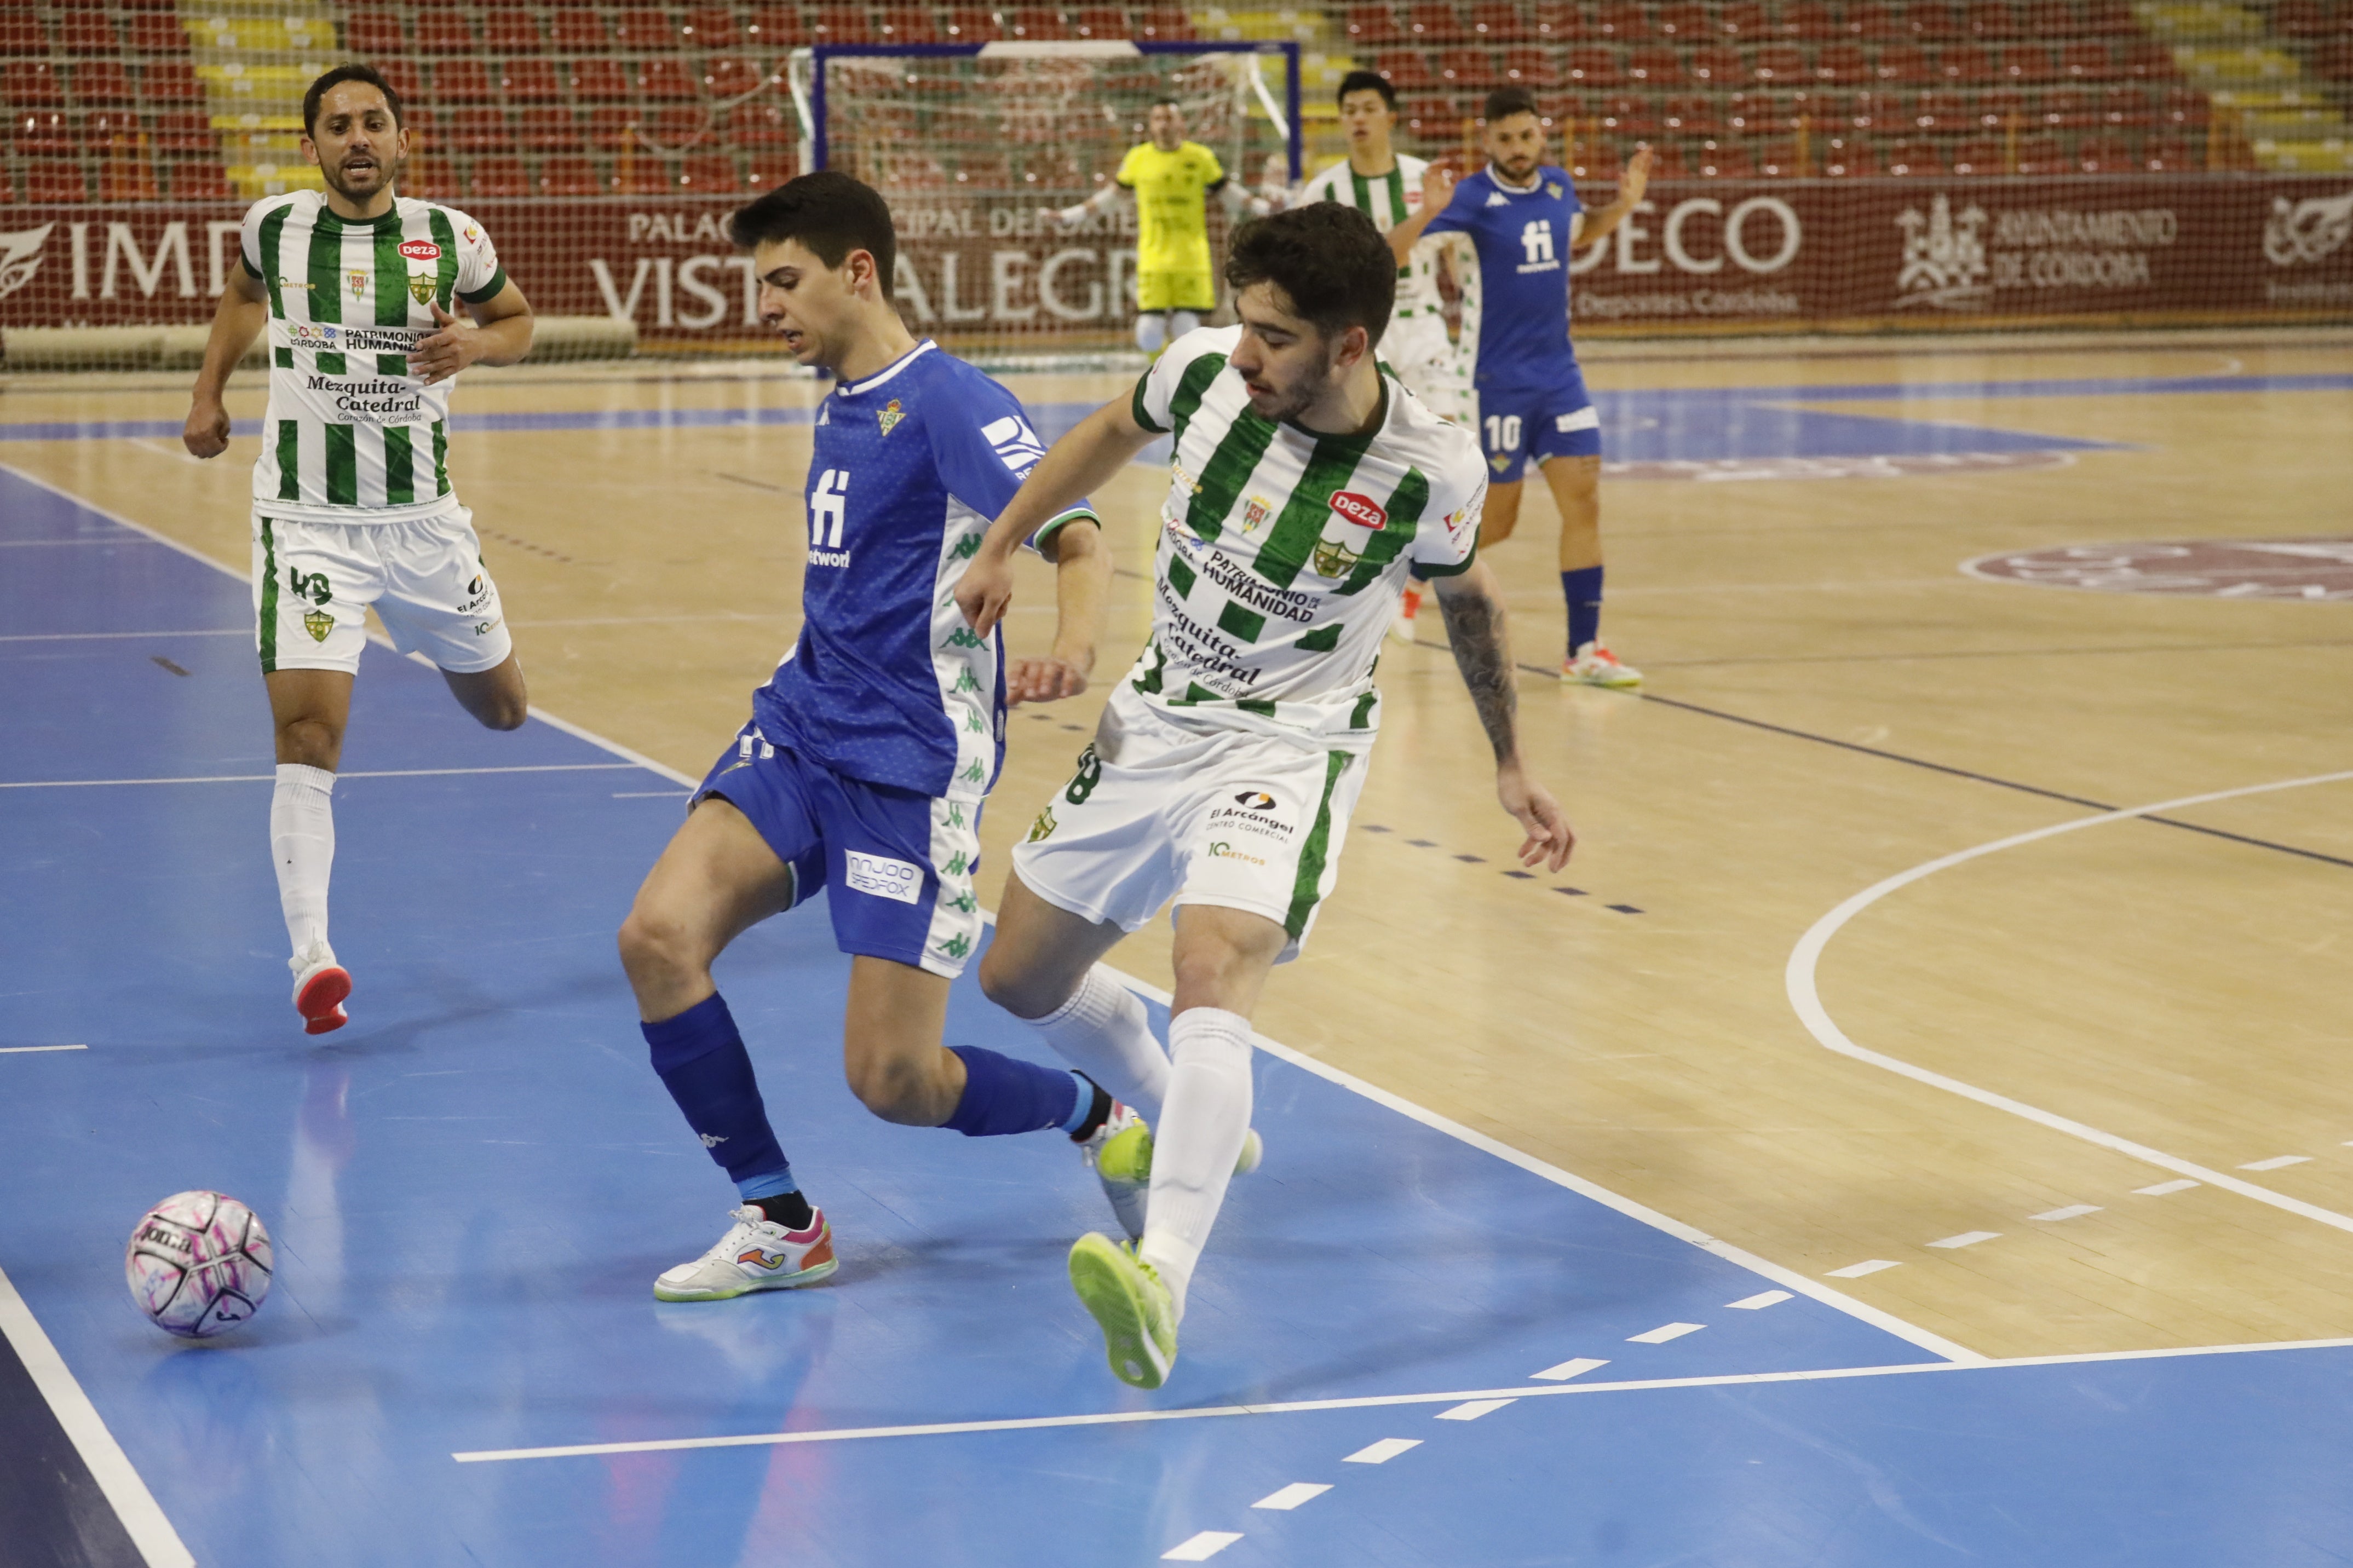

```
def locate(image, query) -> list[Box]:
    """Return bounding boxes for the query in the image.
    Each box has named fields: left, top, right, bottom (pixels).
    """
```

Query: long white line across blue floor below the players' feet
left=450, top=1340, right=2353, bottom=1465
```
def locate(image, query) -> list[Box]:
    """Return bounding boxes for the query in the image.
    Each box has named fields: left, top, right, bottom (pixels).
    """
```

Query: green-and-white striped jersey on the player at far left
left=243, top=191, right=506, bottom=522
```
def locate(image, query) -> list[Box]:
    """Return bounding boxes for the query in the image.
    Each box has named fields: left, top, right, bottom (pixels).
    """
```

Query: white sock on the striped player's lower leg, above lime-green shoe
left=1136, top=1006, right=1250, bottom=1319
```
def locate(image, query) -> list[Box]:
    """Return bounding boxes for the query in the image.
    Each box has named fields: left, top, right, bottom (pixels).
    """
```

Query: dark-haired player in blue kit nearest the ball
left=621, top=171, right=1130, bottom=1300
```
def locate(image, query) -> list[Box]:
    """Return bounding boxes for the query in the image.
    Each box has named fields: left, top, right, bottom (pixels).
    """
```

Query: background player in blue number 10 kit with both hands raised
left=1388, top=87, right=1649, bottom=687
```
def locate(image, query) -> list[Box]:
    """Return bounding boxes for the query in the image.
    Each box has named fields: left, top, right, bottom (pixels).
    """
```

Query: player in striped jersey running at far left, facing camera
left=181, top=66, right=532, bottom=1034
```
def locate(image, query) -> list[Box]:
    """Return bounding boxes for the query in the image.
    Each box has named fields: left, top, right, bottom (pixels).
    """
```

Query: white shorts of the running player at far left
left=254, top=508, right=515, bottom=675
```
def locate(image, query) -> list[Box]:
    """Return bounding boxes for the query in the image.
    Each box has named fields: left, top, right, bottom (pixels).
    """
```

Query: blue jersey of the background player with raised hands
left=1424, top=165, right=1584, bottom=393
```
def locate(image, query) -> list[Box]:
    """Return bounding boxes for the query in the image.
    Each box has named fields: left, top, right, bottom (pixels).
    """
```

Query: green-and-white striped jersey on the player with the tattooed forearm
left=1130, top=327, right=1487, bottom=750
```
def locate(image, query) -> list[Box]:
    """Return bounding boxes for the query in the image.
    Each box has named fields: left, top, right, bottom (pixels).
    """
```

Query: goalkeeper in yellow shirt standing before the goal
left=1045, top=99, right=1270, bottom=355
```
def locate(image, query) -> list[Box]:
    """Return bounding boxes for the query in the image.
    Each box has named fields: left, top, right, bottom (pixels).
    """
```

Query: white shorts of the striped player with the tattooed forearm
left=1014, top=682, right=1370, bottom=964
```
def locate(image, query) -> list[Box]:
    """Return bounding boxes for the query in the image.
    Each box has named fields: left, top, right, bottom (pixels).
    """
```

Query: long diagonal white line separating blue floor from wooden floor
left=0, top=463, right=1983, bottom=1361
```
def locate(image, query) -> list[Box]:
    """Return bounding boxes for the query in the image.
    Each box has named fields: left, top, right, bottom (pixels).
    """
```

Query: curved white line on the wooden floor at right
left=1784, top=771, right=2353, bottom=1232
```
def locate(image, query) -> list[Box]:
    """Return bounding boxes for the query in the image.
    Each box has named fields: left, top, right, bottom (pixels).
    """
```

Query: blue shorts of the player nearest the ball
left=687, top=724, right=981, bottom=981
